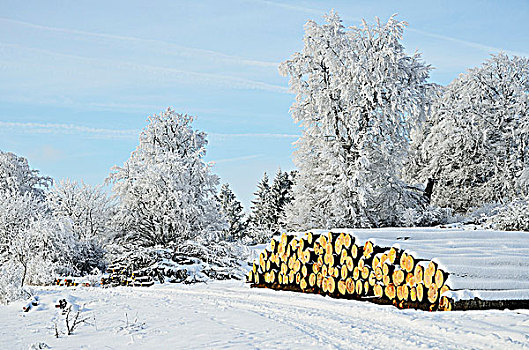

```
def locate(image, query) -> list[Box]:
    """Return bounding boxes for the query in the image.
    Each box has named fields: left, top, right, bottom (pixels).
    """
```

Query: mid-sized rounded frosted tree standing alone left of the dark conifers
left=108, top=109, right=225, bottom=247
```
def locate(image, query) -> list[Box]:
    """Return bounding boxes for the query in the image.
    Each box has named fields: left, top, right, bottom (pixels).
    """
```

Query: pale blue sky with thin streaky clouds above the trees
left=0, top=0, right=529, bottom=208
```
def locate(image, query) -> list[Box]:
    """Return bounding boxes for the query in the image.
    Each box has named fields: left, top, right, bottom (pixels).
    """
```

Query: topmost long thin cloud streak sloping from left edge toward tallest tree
left=0, top=17, right=279, bottom=68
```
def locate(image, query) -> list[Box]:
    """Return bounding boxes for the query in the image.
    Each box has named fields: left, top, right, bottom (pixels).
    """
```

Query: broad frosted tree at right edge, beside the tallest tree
left=417, top=54, right=529, bottom=212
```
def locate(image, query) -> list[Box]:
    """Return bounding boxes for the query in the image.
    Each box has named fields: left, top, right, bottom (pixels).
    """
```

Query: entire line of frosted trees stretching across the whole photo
left=0, top=12, right=529, bottom=302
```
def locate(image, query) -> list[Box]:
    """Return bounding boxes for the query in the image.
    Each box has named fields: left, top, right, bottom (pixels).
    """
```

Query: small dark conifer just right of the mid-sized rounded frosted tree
left=217, top=183, right=247, bottom=240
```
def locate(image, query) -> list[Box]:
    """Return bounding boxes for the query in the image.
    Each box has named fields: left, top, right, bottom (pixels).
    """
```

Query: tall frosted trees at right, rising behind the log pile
left=280, top=12, right=529, bottom=231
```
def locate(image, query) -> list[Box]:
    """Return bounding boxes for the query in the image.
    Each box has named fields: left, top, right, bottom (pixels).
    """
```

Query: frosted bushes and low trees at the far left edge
left=0, top=151, right=115, bottom=302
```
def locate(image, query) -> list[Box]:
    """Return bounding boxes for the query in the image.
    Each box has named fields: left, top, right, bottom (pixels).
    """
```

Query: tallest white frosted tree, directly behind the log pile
left=280, top=12, right=430, bottom=229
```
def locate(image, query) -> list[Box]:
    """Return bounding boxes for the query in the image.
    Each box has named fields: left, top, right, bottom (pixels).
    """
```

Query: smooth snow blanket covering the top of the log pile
left=298, top=226, right=529, bottom=300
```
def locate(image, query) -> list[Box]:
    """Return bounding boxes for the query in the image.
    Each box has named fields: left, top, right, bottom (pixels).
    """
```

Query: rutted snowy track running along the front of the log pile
left=148, top=284, right=527, bottom=349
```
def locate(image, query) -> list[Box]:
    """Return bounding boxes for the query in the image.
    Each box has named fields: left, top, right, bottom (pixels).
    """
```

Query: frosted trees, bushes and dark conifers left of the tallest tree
left=0, top=109, right=288, bottom=302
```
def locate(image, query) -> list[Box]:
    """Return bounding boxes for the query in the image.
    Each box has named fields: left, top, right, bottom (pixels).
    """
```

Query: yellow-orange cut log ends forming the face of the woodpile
left=247, top=232, right=454, bottom=311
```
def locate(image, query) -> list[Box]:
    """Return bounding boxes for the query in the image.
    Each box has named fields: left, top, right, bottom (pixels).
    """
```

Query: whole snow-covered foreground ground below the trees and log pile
left=0, top=281, right=529, bottom=349
